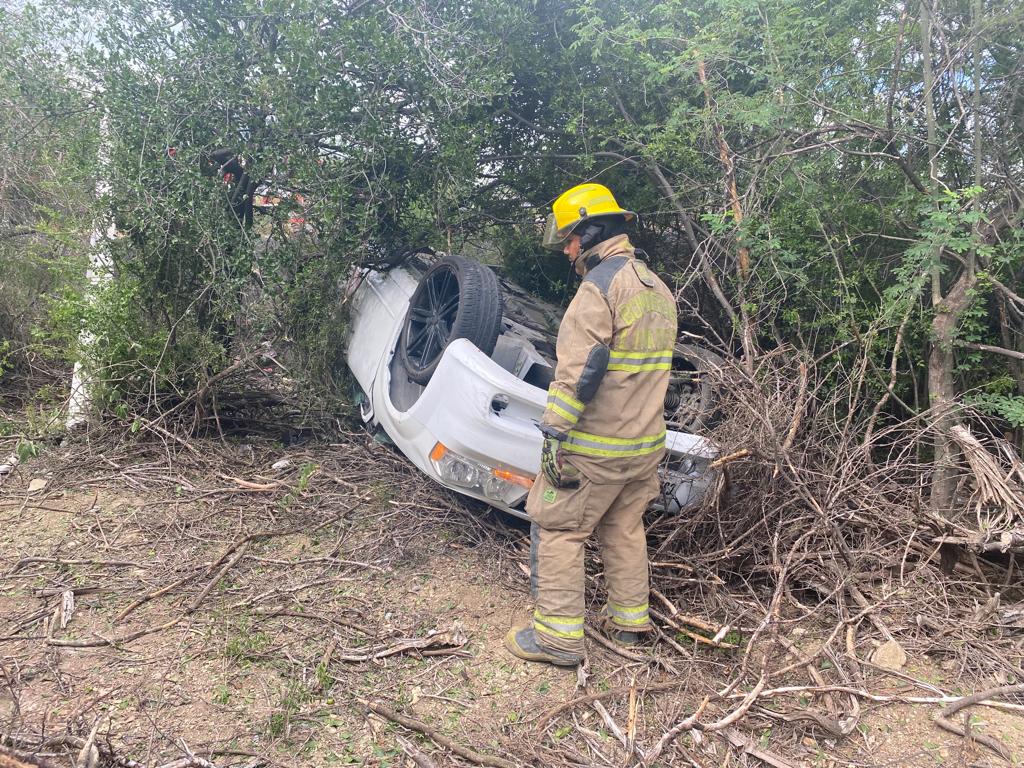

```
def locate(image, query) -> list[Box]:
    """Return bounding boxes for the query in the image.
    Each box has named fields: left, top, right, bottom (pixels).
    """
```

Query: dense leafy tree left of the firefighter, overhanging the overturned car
left=70, top=0, right=520, bottom=405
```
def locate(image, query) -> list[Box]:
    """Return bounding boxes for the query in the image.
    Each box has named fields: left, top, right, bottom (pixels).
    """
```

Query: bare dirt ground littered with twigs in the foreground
left=0, top=435, right=1024, bottom=768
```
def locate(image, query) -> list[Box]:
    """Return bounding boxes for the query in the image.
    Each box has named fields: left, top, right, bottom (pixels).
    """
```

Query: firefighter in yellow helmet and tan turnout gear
left=505, top=183, right=676, bottom=667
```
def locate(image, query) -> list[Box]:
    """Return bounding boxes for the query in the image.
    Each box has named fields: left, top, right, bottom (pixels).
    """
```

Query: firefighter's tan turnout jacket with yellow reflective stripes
left=544, top=234, right=676, bottom=482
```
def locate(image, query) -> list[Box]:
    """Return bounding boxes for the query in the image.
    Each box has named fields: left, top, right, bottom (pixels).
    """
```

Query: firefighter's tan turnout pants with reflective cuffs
left=526, top=473, right=660, bottom=652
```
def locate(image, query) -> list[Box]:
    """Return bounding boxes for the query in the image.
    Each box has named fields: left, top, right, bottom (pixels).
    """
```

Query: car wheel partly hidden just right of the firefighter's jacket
left=665, top=344, right=725, bottom=433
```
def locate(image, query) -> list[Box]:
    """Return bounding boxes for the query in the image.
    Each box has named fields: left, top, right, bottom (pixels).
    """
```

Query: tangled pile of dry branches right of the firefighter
left=651, top=350, right=1024, bottom=681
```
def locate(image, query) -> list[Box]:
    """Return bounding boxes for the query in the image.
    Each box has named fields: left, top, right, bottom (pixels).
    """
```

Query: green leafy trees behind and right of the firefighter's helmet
left=471, top=0, right=1024, bottom=507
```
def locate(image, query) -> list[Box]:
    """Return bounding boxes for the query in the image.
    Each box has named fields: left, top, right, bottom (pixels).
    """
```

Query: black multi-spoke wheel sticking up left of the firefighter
left=398, top=256, right=502, bottom=384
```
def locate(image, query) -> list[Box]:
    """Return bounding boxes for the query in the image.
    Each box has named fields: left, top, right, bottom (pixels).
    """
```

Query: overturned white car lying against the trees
left=347, top=254, right=716, bottom=518
